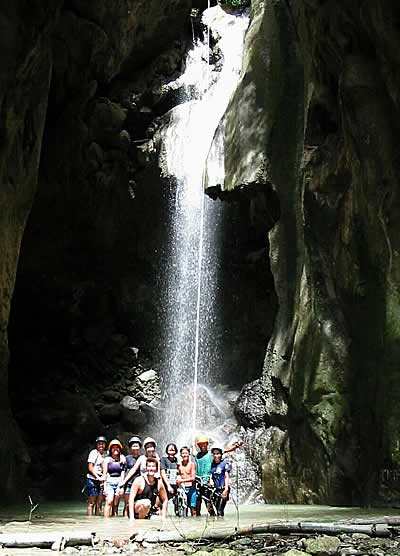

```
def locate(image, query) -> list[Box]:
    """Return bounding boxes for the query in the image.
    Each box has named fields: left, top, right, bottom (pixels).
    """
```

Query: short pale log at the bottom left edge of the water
left=0, top=533, right=97, bottom=550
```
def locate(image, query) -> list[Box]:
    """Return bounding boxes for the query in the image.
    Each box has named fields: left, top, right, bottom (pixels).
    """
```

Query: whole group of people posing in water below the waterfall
left=86, top=435, right=243, bottom=520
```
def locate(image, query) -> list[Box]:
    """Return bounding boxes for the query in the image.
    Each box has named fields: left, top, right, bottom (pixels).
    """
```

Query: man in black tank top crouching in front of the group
left=129, top=457, right=168, bottom=527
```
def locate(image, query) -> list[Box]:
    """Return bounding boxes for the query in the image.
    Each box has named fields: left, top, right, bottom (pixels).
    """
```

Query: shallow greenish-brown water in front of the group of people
left=0, top=502, right=399, bottom=540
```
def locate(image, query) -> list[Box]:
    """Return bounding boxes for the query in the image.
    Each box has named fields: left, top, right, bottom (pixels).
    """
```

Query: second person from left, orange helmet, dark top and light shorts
left=103, top=438, right=126, bottom=517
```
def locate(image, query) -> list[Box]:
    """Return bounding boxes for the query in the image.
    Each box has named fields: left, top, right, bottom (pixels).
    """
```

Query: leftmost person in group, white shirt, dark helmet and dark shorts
left=86, top=436, right=107, bottom=516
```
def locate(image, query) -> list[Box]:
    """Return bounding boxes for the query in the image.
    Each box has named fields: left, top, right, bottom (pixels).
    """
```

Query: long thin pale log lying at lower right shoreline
left=133, top=521, right=392, bottom=543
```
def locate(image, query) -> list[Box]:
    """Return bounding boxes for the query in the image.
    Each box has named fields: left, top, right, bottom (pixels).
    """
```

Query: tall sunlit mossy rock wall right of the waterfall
left=217, top=0, right=400, bottom=503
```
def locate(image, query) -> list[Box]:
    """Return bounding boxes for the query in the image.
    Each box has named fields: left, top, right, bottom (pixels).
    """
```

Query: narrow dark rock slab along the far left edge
left=0, top=2, right=61, bottom=496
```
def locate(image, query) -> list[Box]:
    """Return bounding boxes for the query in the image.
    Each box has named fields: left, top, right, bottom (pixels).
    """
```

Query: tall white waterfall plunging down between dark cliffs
left=160, top=6, right=248, bottom=445
